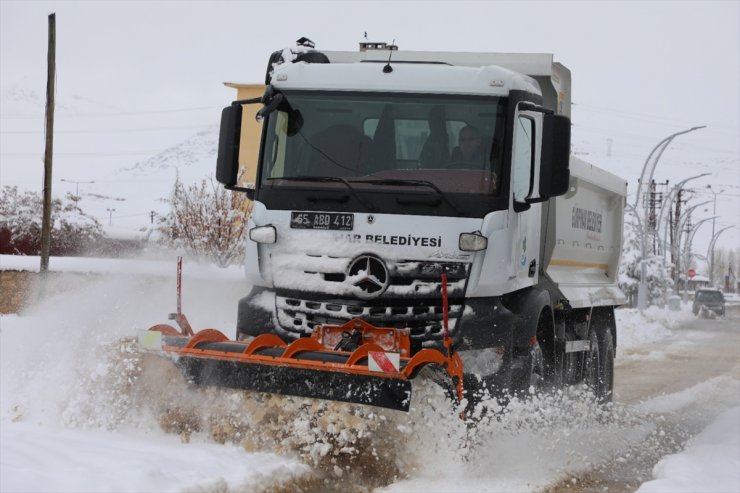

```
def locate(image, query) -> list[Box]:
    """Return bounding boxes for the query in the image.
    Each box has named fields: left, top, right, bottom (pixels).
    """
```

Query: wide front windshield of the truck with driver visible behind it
left=260, top=91, right=506, bottom=195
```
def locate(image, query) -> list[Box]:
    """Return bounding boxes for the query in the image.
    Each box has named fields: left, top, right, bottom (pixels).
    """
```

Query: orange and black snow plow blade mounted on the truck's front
left=141, top=314, right=463, bottom=411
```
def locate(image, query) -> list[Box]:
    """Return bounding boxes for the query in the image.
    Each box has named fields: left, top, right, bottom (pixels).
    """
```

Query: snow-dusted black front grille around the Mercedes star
left=273, top=254, right=470, bottom=343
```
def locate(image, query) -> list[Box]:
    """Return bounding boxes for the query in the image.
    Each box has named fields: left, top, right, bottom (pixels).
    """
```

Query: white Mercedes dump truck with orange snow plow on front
left=143, top=38, right=626, bottom=410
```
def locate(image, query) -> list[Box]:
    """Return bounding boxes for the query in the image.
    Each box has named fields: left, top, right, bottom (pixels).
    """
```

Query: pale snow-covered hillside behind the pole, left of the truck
left=0, top=82, right=219, bottom=236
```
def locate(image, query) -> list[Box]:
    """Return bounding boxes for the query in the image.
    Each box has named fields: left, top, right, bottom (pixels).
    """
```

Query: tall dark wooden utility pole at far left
left=41, top=14, right=56, bottom=277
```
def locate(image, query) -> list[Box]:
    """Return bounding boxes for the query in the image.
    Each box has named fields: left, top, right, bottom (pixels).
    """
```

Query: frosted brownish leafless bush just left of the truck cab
left=159, top=176, right=252, bottom=267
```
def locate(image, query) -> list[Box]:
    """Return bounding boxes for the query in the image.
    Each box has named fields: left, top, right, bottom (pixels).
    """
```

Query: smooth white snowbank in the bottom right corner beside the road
left=637, top=407, right=740, bottom=493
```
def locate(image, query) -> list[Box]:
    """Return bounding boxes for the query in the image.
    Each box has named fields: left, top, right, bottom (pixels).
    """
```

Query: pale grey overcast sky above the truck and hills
left=0, top=0, right=740, bottom=250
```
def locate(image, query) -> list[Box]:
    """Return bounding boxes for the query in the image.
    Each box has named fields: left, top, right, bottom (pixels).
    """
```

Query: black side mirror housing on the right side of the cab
left=539, top=113, right=570, bottom=200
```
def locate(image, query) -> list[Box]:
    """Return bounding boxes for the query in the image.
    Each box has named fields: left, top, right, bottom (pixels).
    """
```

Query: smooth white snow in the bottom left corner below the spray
left=0, top=422, right=307, bottom=493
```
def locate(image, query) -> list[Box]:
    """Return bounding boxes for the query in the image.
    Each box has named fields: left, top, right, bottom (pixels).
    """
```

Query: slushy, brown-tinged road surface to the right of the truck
left=549, top=318, right=740, bottom=493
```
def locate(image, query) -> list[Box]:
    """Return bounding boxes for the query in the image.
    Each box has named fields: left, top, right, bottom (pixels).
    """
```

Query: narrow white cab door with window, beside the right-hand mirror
left=509, top=112, right=542, bottom=289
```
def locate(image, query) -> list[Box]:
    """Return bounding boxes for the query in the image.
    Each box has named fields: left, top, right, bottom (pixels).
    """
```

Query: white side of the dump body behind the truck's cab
left=544, top=157, right=627, bottom=308
